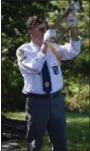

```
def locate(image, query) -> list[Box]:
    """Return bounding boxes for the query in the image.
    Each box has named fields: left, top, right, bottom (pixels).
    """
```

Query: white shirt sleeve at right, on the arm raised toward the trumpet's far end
left=54, top=40, right=81, bottom=60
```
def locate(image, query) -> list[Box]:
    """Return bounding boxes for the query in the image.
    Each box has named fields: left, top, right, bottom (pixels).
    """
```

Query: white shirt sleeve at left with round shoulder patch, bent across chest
left=16, top=48, right=46, bottom=73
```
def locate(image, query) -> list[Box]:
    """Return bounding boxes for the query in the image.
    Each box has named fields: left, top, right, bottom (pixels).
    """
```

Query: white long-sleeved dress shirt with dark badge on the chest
left=16, top=41, right=81, bottom=94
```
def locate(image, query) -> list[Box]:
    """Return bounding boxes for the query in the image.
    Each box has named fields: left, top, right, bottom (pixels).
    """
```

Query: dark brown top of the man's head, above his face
left=26, top=14, right=45, bottom=29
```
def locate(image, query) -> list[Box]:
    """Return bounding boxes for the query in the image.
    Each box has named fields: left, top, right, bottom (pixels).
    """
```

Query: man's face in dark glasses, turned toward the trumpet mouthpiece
left=30, top=23, right=45, bottom=43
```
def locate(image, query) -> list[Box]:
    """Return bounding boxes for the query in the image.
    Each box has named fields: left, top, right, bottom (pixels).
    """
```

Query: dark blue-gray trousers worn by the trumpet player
left=26, top=95, right=67, bottom=151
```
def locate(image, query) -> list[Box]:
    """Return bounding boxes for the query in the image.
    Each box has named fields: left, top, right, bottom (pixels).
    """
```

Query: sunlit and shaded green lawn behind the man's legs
left=4, top=112, right=90, bottom=151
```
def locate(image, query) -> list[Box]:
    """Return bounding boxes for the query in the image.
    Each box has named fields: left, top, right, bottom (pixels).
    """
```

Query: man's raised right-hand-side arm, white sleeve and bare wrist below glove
left=54, top=28, right=81, bottom=60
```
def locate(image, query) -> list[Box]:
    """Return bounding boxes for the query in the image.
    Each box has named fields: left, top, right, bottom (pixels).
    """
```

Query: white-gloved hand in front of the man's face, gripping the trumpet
left=43, top=29, right=56, bottom=44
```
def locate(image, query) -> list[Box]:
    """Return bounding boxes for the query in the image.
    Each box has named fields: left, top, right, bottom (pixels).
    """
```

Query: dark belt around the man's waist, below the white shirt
left=27, top=90, right=60, bottom=98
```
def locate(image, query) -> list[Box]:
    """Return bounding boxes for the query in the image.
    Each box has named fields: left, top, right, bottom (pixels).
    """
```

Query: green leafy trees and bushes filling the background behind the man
left=1, top=0, right=90, bottom=111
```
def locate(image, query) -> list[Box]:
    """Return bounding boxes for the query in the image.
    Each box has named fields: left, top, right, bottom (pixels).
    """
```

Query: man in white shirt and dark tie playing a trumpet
left=16, top=15, right=81, bottom=151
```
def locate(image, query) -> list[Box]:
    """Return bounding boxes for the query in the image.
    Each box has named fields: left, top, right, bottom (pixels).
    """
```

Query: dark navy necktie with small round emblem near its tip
left=42, top=61, right=52, bottom=94
